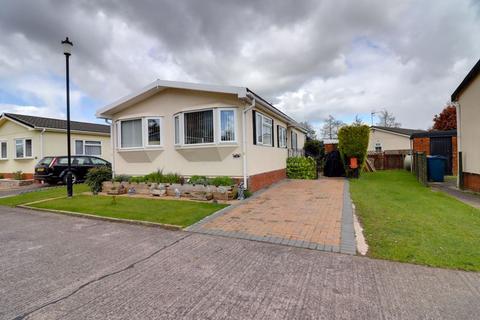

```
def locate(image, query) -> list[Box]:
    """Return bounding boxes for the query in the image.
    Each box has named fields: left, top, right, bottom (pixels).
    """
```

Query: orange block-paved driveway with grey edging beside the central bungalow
left=187, top=178, right=355, bottom=253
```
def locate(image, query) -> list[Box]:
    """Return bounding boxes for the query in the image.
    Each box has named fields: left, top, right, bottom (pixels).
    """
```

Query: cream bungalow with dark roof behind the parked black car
left=0, top=113, right=112, bottom=179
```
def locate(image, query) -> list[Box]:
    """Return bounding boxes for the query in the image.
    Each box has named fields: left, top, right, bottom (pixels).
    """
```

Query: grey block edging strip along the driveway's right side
left=340, top=179, right=356, bottom=254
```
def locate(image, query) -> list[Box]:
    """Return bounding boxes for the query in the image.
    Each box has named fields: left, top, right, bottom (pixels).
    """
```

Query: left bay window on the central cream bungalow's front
left=117, top=117, right=162, bottom=149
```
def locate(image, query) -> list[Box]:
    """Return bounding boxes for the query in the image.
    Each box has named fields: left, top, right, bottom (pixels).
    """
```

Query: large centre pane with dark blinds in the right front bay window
left=184, top=110, right=214, bottom=144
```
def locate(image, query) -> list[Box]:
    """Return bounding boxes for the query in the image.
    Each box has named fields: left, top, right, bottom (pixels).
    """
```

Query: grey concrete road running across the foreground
left=0, top=207, right=480, bottom=320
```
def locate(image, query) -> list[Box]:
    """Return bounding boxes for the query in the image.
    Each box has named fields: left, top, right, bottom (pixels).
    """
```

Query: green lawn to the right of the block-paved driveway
left=350, top=171, right=480, bottom=271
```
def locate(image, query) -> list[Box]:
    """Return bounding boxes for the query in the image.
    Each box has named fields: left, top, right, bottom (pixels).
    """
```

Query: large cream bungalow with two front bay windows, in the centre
left=97, top=80, right=306, bottom=191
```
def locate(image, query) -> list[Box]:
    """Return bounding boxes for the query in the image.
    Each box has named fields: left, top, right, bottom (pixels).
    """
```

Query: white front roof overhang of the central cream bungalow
left=95, top=79, right=247, bottom=119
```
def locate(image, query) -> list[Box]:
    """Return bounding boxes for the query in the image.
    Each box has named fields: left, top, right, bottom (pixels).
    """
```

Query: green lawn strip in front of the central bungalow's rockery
left=25, top=195, right=227, bottom=227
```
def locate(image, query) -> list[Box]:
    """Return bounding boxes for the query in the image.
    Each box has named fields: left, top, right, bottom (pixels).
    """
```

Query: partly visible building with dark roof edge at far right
left=451, top=60, right=480, bottom=192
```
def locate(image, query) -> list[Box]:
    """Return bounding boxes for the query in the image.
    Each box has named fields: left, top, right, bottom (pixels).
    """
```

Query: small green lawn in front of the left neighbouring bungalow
left=0, top=184, right=89, bottom=207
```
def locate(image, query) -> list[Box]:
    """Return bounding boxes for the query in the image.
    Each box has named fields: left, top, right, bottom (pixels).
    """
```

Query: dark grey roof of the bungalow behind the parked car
left=3, top=113, right=110, bottom=134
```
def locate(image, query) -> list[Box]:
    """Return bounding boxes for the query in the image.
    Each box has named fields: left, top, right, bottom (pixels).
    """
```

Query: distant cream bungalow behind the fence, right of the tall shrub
left=368, top=126, right=426, bottom=154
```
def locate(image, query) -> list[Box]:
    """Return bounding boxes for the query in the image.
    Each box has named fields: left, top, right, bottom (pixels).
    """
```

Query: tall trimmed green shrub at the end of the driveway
left=338, top=124, right=370, bottom=176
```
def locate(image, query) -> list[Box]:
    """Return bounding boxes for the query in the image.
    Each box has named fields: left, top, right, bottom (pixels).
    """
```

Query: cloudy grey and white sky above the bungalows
left=0, top=0, right=480, bottom=132
